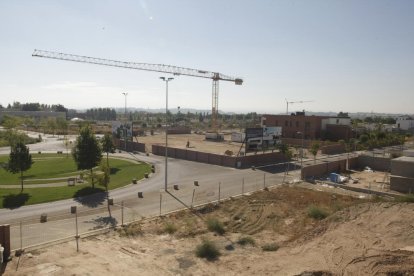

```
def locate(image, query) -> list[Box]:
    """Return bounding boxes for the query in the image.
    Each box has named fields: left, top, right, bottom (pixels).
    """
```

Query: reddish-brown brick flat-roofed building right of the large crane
left=261, top=112, right=352, bottom=141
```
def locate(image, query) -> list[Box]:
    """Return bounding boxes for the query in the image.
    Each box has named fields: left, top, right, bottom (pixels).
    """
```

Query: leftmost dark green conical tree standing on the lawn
left=7, top=142, right=33, bottom=191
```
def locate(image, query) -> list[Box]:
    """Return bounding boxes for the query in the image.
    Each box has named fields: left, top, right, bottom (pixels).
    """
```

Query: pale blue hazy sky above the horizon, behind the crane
left=0, top=0, right=414, bottom=114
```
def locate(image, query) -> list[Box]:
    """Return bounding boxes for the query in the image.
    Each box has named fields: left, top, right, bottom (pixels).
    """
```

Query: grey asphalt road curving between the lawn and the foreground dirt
left=0, top=134, right=299, bottom=249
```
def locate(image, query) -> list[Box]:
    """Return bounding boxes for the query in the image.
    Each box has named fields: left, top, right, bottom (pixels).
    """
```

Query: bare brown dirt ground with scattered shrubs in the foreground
left=5, top=186, right=414, bottom=275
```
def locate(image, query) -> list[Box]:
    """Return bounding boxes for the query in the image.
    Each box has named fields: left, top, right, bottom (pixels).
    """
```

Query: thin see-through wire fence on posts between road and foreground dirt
left=6, top=168, right=299, bottom=251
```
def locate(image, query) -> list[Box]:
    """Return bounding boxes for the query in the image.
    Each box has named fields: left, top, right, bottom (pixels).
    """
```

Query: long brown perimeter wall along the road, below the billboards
left=152, top=145, right=284, bottom=168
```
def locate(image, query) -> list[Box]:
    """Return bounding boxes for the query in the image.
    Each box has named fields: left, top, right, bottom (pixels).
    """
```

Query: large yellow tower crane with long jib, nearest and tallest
left=32, top=49, right=243, bottom=132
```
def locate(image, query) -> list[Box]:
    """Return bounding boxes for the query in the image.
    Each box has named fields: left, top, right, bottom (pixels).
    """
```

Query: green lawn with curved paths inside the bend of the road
left=0, top=154, right=151, bottom=208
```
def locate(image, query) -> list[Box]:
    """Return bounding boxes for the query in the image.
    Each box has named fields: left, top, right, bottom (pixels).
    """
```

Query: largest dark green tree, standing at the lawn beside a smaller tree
left=72, top=126, right=102, bottom=188
